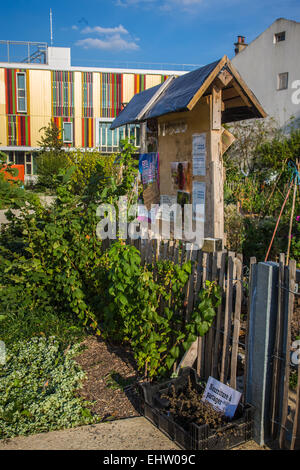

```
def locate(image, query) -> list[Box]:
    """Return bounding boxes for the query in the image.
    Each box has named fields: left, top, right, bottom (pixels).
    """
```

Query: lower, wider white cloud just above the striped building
left=75, top=34, right=139, bottom=51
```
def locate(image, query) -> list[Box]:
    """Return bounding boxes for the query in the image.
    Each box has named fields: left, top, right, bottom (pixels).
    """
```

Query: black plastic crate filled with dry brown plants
left=141, top=368, right=253, bottom=450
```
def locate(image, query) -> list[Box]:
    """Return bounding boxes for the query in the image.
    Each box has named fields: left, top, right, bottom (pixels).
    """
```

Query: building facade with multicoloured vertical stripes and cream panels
left=0, top=50, right=183, bottom=179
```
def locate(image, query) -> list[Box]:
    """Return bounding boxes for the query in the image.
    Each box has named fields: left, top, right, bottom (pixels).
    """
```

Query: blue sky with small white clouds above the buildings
left=0, top=0, right=300, bottom=70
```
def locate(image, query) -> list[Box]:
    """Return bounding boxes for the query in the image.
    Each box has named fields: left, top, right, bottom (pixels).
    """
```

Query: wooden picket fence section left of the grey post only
left=123, top=239, right=250, bottom=396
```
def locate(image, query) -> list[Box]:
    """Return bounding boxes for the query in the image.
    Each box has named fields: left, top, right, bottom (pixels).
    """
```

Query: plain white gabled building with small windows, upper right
left=232, top=18, right=300, bottom=127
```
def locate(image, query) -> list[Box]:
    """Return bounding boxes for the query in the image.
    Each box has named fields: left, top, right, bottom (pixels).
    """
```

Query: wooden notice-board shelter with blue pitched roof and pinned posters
left=111, top=56, right=266, bottom=246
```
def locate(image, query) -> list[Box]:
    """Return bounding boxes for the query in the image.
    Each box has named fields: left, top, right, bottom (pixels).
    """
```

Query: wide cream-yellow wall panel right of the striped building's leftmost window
left=29, top=70, right=52, bottom=147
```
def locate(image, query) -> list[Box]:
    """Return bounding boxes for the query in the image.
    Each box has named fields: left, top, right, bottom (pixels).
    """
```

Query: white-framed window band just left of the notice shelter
left=96, top=118, right=140, bottom=153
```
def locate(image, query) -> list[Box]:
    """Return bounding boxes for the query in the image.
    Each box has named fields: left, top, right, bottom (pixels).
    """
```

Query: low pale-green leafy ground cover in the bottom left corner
left=0, top=338, right=98, bottom=439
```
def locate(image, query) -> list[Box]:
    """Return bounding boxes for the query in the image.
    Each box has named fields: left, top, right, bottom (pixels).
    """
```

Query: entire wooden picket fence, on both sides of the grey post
left=103, top=239, right=300, bottom=449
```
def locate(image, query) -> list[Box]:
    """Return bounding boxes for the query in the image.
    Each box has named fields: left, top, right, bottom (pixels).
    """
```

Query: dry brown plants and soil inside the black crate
left=161, top=377, right=229, bottom=436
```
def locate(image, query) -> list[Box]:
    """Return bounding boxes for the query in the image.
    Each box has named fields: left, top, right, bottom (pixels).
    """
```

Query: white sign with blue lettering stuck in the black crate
left=202, top=377, right=241, bottom=418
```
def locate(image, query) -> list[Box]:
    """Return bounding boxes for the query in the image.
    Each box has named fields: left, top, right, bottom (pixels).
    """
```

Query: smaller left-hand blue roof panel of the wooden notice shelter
left=110, top=85, right=161, bottom=129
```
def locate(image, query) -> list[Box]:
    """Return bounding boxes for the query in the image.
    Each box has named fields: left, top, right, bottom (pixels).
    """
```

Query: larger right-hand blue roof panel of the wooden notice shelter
left=144, top=60, right=220, bottom=119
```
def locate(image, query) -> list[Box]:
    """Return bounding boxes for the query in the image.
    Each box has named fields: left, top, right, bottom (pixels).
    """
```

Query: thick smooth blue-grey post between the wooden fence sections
left=246, top=262, right=278, bottom=445
